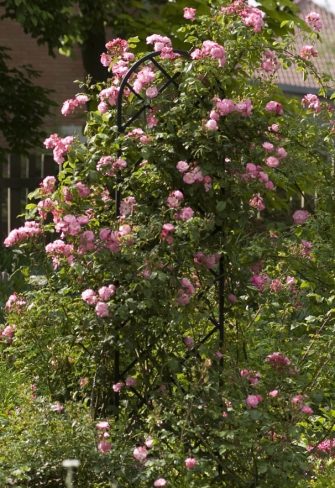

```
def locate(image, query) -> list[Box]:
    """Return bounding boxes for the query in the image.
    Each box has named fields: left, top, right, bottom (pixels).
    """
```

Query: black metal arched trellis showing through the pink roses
left=114, top=49, right=225, bottom=416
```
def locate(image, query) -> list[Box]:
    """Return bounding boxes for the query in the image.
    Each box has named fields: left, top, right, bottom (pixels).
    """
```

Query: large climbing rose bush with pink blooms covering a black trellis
left=2, top=0, right=335, bottom=487
